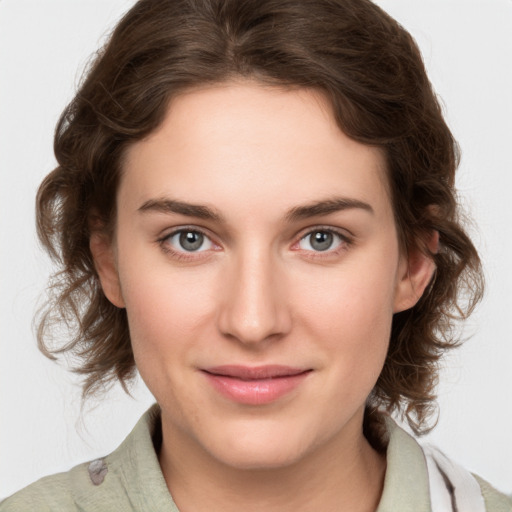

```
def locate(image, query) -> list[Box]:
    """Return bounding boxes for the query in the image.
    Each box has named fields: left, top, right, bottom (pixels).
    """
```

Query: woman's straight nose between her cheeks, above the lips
left=218, top=249, right=291, bottom=347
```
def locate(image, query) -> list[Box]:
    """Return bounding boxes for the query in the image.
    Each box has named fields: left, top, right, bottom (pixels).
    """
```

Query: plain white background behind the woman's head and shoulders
left=0, top=0, right=512, bottom=498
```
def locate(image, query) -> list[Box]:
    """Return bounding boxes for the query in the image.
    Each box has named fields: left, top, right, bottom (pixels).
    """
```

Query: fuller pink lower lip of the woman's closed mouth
left=204, top=371, right=310, bottom=405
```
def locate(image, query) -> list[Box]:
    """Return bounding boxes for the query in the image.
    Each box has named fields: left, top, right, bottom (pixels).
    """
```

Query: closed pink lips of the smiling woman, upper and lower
left=203, top=365, right=311, bottom=405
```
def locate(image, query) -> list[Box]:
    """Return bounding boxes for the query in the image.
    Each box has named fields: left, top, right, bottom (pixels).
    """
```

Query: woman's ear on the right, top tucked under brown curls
left=393, top=231, right=439, bottom=313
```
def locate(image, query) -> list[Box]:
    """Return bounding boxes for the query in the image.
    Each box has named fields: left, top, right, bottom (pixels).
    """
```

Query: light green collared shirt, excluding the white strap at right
left=0, top=405, right=512, bottom=512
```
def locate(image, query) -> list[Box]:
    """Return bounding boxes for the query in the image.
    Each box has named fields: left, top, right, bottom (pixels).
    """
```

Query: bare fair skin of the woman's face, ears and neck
left=91, top=82, right=434, bottom=512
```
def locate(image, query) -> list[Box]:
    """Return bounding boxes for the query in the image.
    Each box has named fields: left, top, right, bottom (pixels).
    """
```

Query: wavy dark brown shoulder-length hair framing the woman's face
left=37, top=0, right=483, bottom=432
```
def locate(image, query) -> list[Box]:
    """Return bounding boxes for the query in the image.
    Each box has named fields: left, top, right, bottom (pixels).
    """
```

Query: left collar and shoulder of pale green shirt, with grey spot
left=0, top=406, right=177, bottom=512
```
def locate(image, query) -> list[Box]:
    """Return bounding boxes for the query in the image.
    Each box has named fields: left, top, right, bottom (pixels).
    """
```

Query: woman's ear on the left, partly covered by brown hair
left=89, top=231, right=125, bottom=308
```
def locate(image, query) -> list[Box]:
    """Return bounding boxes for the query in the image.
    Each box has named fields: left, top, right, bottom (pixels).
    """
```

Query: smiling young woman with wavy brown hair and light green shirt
left=2, top=0, right=510, bottom=512
